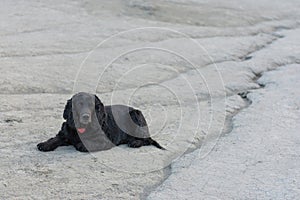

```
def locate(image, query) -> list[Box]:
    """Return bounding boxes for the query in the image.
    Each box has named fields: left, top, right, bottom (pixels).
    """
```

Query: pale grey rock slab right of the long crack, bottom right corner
left=148, top=64, right=300, bottom=199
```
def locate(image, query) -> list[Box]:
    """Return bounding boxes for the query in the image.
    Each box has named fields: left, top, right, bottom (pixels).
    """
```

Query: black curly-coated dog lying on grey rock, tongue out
left=37, top=92, right=164, bottom=152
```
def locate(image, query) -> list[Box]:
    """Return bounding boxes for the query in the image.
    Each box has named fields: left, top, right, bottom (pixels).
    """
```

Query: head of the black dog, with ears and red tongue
left=63, top=92, right=106, bottom=133
